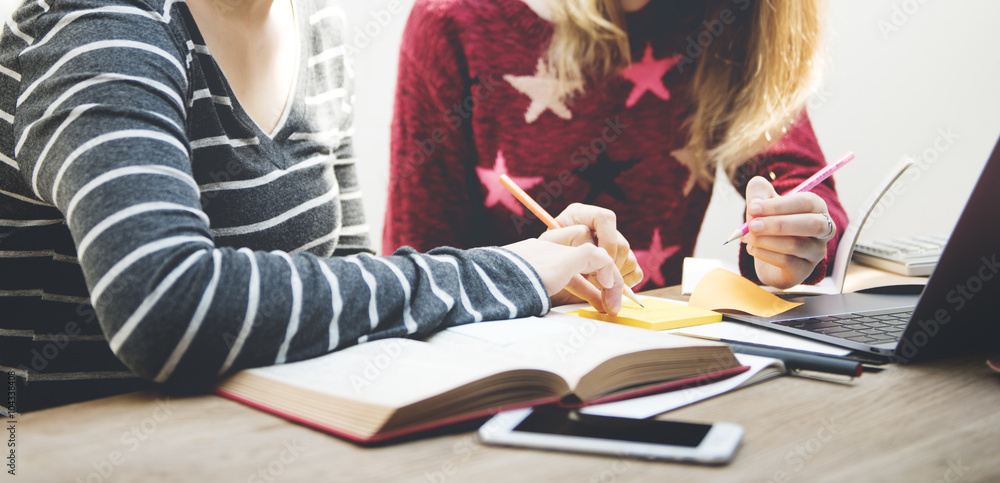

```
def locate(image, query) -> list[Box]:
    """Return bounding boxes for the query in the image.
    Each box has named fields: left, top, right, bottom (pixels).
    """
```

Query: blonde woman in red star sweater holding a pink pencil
left=383, top=0, right=847, bottom=289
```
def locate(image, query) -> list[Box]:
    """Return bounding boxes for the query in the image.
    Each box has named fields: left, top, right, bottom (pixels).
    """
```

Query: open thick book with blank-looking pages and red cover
left=216, top=314, right=747, bottom=442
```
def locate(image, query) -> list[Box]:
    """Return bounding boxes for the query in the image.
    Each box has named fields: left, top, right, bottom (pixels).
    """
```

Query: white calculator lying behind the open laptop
left=853, top=235, right=948, bottom=277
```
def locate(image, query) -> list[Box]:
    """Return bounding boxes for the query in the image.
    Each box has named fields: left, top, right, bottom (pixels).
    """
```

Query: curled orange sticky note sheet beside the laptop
left=688, top=268, right=802, bottom=317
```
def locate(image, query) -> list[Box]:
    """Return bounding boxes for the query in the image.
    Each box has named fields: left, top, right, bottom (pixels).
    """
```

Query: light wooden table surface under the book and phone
left=15, top=292, right=1000, bottom=483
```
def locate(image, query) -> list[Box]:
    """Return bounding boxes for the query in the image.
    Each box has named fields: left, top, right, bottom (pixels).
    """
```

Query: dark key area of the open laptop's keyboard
left=775, top=309, right=913, bottom=344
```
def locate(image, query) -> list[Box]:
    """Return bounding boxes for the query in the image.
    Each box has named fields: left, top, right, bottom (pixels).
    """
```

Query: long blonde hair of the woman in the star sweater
left=546, top=0, right=822, bottom=187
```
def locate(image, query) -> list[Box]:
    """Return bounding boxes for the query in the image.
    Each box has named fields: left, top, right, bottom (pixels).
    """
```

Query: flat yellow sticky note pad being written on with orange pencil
left=576, top=298, right=722, bottom=330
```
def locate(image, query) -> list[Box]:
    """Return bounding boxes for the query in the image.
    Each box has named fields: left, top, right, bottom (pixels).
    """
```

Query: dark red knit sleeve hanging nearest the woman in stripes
left=382, top=0, right=483, bottom=252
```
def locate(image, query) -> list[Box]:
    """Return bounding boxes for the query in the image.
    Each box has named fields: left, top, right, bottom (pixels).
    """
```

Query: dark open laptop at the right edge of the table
left=727, top=139, right=1000, bottom=363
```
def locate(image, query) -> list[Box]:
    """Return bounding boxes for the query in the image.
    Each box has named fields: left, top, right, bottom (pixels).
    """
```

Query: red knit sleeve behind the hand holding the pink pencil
left=733, top=109, right=848, bottom=284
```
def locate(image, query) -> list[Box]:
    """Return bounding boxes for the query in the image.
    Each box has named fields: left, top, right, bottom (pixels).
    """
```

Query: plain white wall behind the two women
left=0, top=0, right=1000, bottom=258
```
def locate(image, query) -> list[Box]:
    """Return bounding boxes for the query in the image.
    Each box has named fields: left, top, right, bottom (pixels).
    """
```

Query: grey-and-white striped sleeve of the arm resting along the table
left=14, top=2, right=549, bottom=383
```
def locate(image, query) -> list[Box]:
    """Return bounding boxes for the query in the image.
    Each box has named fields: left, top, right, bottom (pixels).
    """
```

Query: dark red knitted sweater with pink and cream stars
left=383, top=0, right=847, bottom=289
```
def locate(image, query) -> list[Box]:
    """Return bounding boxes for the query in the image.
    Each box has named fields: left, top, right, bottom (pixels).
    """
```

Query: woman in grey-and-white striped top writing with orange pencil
left=0, top=0, right=641, bottom=408
